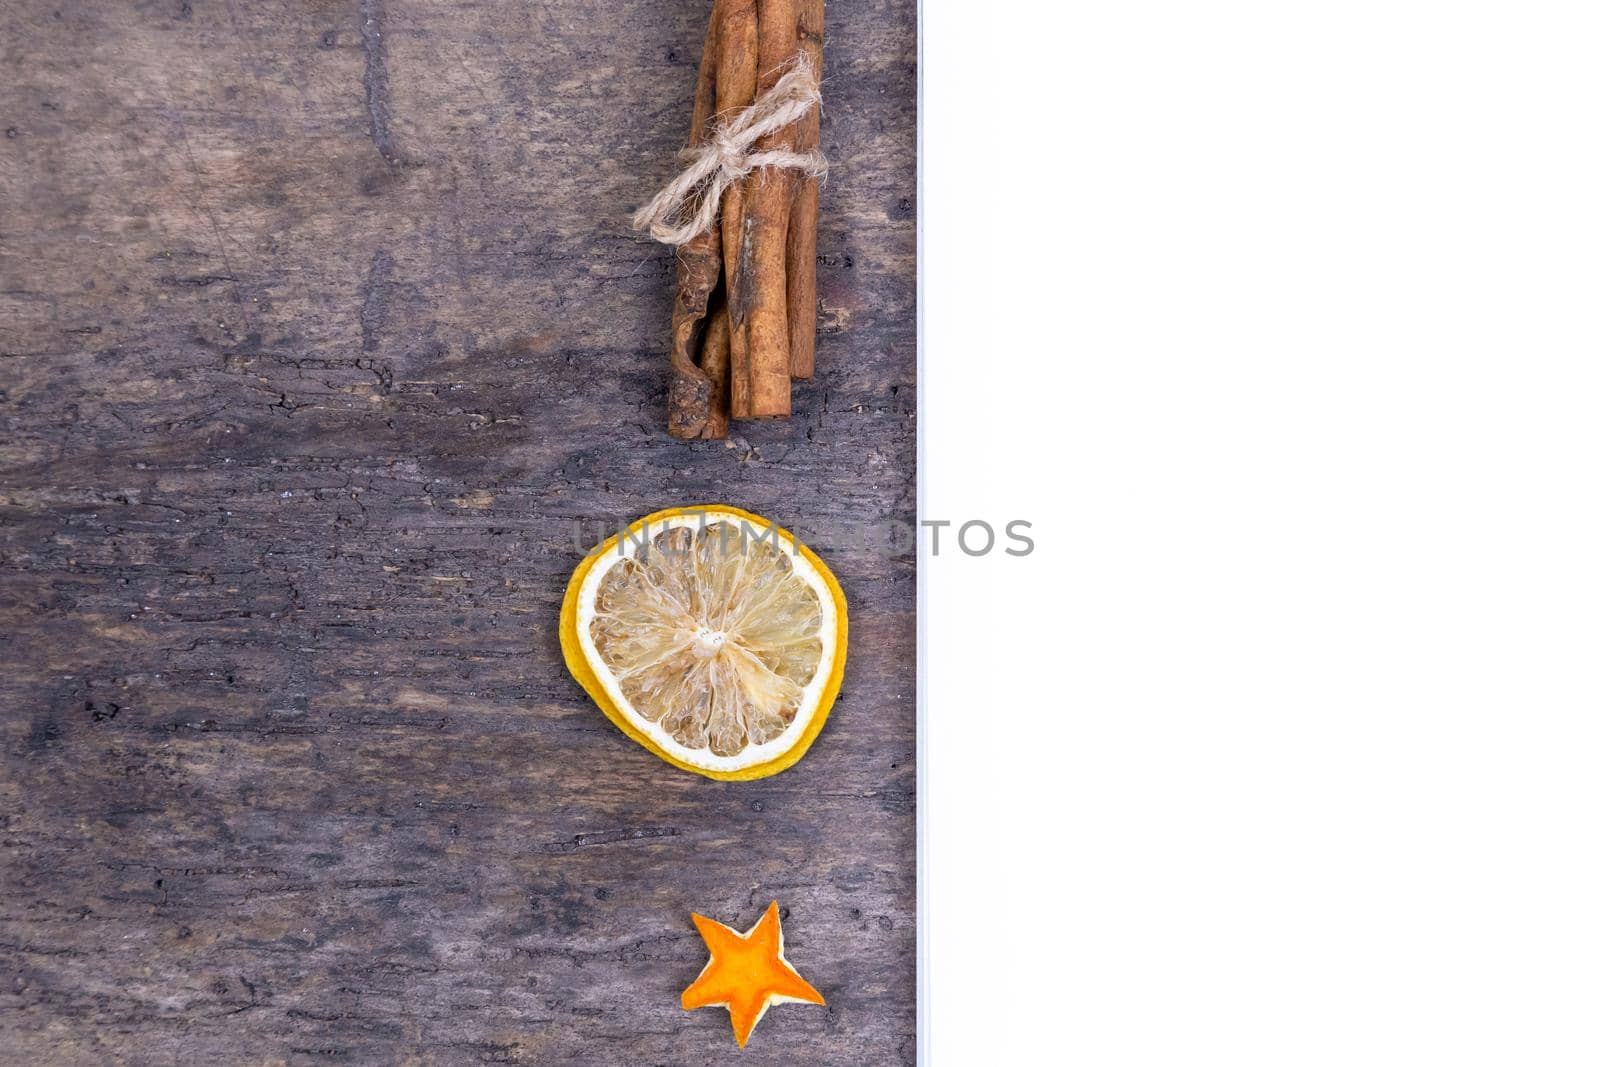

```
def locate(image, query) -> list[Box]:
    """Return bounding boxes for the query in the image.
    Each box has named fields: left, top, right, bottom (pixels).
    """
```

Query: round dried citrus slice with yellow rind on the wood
left=562, top=504, right=846, bottom=781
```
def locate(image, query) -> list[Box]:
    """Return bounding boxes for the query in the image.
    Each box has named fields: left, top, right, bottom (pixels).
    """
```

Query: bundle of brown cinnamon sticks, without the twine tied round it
left=667, top=0, right=822, bottom=440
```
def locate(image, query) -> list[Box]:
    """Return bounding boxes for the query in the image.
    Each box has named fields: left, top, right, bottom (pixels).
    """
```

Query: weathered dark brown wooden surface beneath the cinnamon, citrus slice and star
left=0, top=0, right=915, bottom=1065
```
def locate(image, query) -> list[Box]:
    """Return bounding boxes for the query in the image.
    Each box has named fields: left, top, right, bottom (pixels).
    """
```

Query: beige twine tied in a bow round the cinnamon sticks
left=634, top=54, right=827, bottom=245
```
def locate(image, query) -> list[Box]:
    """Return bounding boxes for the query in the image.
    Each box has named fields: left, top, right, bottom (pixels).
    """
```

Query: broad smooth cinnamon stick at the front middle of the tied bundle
left=734, top=0, right=800, bottom=419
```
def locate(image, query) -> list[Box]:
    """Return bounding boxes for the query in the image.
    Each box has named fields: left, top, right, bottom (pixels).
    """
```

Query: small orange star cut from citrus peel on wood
left=683, top=901, right=824, bottom=1048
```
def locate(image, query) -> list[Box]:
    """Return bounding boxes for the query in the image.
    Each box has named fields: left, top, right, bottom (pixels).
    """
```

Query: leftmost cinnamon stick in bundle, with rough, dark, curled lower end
left=667, top=0, right=728, bottom=440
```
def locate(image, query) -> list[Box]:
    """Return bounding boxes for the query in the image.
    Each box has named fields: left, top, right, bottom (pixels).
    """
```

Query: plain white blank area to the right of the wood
left=921, top=0, right=1600, bottom=1067
